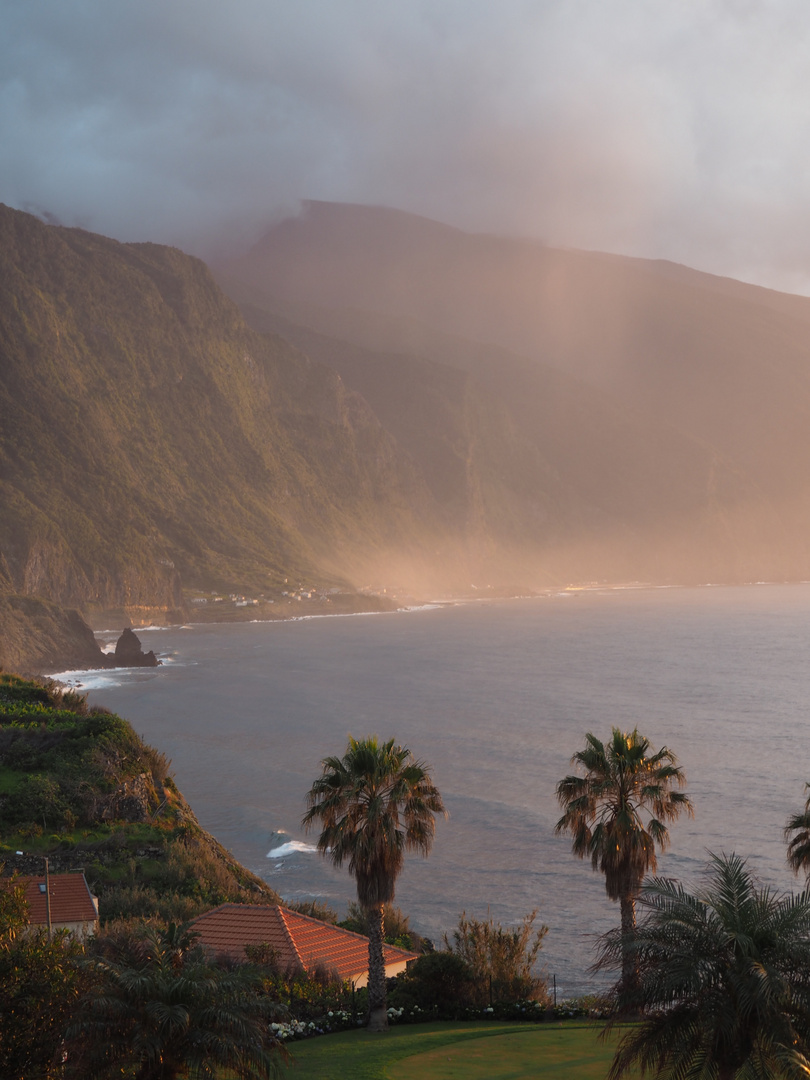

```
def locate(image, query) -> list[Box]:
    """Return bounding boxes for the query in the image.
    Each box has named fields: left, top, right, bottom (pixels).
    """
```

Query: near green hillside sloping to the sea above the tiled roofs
left=0, top=673, right=279, bottom=921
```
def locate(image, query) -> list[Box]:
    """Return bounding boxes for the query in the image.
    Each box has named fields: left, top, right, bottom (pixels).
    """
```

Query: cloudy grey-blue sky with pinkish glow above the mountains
left=0, top=0, right=810, bottom=294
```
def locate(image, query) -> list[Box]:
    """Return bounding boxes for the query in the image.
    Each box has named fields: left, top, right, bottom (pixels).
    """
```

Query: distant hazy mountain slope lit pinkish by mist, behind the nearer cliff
left=218, top=202, right=810, bottom=584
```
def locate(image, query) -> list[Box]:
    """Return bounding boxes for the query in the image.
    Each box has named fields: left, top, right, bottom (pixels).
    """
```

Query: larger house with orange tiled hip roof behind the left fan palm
left=191, top=904, right=417, bottom=989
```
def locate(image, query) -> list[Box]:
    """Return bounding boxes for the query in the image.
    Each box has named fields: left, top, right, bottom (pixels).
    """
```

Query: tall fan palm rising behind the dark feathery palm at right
left=554, top=728, right=693, bottom=982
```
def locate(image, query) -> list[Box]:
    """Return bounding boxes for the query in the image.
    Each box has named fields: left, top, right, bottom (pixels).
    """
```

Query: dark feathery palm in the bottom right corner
left=596, top=854, right=810, bottom=1080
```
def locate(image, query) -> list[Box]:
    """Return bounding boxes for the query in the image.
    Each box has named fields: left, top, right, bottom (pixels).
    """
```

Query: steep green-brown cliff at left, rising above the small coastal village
left=0, top=198, right=457, bottom=666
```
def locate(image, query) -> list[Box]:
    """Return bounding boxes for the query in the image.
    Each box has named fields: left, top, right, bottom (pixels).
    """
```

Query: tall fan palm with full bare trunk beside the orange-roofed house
left=303, top=735, right=446, bottom=1031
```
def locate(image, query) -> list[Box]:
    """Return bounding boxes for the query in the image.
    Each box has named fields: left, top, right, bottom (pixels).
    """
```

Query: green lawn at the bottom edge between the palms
left=288, top=1021, right=630, bottom=1080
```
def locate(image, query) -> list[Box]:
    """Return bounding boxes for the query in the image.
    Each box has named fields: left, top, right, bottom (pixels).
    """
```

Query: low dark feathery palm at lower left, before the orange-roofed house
left=67, top=927, right=285, bottom=1080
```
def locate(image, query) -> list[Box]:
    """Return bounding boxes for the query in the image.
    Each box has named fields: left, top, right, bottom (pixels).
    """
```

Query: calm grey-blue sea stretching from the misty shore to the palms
left=54, top=584, right=810, bottom=998
